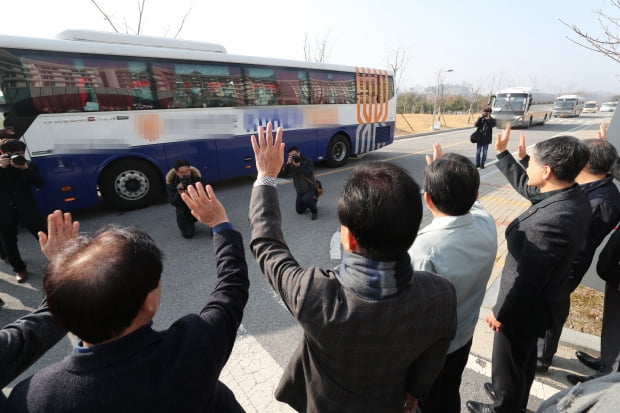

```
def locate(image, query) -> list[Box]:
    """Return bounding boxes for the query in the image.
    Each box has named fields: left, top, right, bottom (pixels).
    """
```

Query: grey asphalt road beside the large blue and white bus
left=0, top=114, right=610, bottom=408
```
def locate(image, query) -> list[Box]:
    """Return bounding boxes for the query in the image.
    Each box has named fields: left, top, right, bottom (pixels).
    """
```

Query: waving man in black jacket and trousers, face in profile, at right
left=467, top=125, right=591, bottom=413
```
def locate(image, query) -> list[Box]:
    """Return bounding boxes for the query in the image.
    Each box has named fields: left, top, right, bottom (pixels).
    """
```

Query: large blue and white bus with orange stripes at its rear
left=0, top=30, right=396, bottom=211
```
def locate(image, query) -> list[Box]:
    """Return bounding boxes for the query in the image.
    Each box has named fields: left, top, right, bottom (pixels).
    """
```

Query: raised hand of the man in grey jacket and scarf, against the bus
left=250, top=122, right=284, bottom=178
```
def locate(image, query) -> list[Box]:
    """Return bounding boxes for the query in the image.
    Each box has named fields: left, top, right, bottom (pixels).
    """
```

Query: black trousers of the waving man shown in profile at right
left=491, top=330, right=538, bottom=413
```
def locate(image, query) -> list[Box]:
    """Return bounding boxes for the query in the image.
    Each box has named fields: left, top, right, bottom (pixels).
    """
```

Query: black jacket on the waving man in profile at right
left=493, top=152, right=591, bottom=337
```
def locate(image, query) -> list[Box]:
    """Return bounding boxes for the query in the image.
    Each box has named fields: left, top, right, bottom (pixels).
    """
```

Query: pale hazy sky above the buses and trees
left=0, top=0, right=620, bottom=97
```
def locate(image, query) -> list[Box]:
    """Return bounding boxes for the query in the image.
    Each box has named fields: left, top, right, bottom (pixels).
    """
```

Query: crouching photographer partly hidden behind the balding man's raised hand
left=166, top=159, right=202, bottom=238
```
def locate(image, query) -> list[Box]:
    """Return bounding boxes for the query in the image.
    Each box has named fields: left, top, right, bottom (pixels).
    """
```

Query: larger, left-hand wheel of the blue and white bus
left=99, top=158, right=163, bottom=210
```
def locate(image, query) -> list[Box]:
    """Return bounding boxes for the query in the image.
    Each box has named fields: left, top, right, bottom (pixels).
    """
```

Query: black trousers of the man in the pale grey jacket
left=420, top=340, right=472, bottom=413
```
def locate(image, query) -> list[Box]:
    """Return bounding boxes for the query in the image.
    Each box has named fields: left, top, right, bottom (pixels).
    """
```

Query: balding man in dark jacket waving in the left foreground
left=7, top=183, right=249, bottom=413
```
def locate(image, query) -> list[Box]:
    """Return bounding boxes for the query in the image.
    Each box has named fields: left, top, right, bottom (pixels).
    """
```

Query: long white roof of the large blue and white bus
left=0, top=30, right=394, bottom=76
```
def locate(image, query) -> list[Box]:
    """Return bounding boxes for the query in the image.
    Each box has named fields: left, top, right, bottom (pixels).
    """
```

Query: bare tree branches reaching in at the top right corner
left=560, top=0, right=620, bottom=63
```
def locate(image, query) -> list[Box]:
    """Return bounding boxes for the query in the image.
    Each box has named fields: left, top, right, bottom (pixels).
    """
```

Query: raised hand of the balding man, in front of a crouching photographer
left=181, top=182, right=229, bottom=228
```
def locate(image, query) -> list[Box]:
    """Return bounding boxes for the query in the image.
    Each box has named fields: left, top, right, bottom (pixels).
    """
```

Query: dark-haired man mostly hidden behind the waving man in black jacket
left=536, top=139, right=620, bottom=374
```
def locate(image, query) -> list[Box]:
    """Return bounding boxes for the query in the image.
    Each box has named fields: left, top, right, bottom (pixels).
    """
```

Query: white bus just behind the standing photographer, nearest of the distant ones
left=490, top=87, right=555, bottom=128
